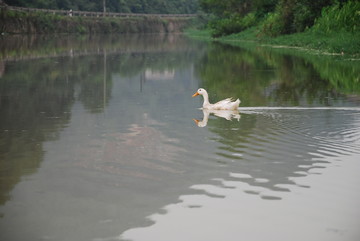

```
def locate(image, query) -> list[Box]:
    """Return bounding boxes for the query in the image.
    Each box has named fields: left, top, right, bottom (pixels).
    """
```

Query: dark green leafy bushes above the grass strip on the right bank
left=199, top=0, right=360, bottom=37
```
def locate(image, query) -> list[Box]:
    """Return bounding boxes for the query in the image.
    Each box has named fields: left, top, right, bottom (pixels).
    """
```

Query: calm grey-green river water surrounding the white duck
left=0, top=35, right=360, bottom=241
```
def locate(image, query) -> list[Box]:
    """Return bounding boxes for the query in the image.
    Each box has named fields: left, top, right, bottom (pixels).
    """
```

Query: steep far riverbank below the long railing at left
left=0, top=8, right=191, bottom=35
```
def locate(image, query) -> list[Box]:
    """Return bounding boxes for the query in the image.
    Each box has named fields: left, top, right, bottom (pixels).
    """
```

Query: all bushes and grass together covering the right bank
left=188, top=0, right=360, bottom=57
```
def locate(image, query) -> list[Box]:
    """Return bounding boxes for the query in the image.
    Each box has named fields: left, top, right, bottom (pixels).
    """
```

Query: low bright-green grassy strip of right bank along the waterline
left=185, top=27, right=360, bottom=59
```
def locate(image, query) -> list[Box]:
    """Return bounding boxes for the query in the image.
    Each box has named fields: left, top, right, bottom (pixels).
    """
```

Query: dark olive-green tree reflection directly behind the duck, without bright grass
left=197, top=44, right=348, bottom=106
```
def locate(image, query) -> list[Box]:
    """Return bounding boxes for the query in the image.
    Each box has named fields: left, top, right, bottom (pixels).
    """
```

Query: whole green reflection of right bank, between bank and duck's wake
left=196, top=43, right=360, bottom=106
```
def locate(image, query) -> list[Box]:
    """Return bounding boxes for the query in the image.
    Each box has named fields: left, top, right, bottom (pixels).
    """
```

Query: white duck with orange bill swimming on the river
left=192, top=88, right=240, bottom=110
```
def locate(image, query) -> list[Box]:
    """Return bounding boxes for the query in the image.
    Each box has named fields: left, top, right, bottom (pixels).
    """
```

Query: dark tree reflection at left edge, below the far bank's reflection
left=0, top=52, right=111, bottom=203
